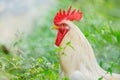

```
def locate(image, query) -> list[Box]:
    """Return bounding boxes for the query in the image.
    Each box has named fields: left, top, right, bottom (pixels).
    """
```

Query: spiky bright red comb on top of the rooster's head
left=54, top=6, right=82, bottom=25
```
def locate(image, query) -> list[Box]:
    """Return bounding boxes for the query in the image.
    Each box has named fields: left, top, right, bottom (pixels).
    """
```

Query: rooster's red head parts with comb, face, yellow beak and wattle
left=52, top=6, right=82, bottom=46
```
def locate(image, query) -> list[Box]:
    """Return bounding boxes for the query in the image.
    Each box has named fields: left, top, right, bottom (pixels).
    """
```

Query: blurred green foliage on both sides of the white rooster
left=0, top=0, right=120, bottom=80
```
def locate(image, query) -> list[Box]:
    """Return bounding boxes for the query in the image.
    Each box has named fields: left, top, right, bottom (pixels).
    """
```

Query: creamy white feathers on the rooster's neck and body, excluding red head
left=59, top=20, right=120, bottom=80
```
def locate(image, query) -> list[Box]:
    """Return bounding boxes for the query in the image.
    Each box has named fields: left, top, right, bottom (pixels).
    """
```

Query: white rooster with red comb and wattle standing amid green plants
left=52, top=6, right=120, bottom=80
